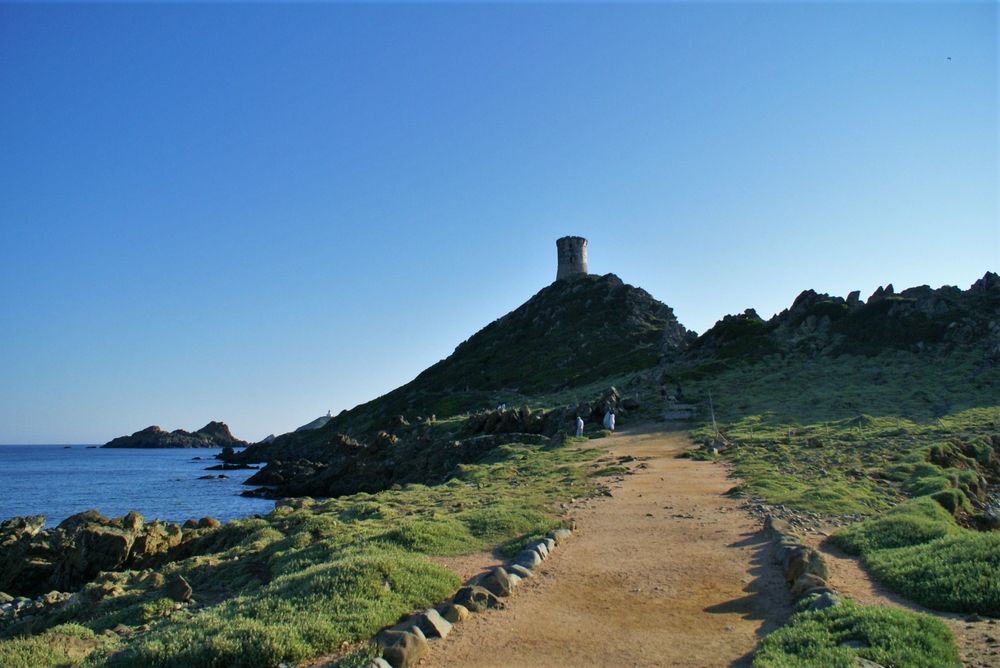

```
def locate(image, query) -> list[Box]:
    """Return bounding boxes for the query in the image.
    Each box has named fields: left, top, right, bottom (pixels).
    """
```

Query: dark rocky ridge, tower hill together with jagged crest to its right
left=231, top=273, right=1000, bottom=497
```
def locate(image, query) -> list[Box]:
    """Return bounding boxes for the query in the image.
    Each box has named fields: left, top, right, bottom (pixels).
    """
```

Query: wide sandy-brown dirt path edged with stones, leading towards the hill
left=423, top=431, right=790, bottom=668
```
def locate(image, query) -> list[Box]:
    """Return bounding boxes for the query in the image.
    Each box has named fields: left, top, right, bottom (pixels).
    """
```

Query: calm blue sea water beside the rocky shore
left=0, top=445, right=274, bottom=526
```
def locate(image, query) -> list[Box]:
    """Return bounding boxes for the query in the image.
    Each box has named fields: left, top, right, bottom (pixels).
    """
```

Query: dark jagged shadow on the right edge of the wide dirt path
left=704, top=531, right=792, bottom=666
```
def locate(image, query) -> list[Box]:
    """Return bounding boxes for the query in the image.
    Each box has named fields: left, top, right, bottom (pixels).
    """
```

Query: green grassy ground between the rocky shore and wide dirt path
left=0, top=439, right=601, bottom=668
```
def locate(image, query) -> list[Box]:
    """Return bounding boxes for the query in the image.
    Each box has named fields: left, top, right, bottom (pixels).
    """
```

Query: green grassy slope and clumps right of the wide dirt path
left=683, top=350, right=1000, bottom=667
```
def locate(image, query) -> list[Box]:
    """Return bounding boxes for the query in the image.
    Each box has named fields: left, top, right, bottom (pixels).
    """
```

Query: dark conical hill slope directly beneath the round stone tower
left=250, top=274, right=695, bottom=446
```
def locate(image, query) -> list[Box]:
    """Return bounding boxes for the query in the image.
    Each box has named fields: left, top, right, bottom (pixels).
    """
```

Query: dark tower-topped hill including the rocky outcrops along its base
left=230, top=274, right=694, bottom=496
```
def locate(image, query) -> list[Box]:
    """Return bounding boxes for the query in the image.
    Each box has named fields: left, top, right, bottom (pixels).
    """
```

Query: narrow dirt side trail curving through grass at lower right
left=804, top=535, right=1000, bottom=668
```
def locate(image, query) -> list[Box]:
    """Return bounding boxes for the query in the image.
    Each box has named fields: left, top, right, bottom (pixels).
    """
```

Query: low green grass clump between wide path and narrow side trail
left=753, top=601, right=962, bottom=668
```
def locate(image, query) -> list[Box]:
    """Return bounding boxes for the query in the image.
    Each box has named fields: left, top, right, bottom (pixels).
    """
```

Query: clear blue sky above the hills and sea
left=0, top=3, right=1000, bottom=443
